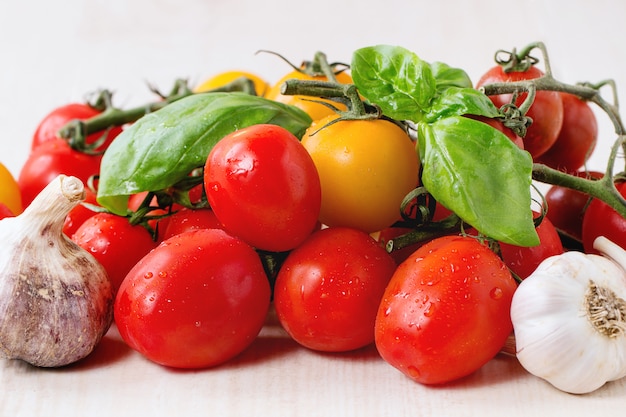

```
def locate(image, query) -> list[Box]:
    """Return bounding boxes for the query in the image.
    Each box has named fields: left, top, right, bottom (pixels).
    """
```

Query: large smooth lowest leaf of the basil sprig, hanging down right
left=418, top=116, right=539, bottom=246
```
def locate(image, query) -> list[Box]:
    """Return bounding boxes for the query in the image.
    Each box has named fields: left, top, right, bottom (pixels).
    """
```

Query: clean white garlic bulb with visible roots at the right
left=511, top=237, right=626, bottom=394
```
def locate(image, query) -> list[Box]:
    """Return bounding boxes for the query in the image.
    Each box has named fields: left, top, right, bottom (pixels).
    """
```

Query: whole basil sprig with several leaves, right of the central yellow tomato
left=351, top=45, right=539, bottom=246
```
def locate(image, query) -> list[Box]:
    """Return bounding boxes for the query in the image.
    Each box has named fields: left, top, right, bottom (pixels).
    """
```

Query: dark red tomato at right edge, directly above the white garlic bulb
left=582, top=182, right=626, bottom=253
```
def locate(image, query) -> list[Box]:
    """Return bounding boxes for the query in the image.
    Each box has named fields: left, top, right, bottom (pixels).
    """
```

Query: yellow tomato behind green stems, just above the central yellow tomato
left=265, top=71, right=352, bottom=121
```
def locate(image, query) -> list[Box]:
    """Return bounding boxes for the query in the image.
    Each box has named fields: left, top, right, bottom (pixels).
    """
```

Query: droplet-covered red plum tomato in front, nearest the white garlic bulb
left=375, top=236, right=517, bottom=384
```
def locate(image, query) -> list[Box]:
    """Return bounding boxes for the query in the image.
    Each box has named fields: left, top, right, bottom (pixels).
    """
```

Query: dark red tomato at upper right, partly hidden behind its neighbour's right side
left=537, top=93, right=598, bottom=173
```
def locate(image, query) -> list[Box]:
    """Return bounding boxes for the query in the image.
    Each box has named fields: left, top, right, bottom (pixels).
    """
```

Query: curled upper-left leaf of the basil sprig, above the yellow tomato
left=350, top=45, right=436, bottom=121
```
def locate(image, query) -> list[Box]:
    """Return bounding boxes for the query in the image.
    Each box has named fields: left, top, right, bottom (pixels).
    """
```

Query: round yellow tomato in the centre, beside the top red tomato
left=302, top=115, right=420, bottom=233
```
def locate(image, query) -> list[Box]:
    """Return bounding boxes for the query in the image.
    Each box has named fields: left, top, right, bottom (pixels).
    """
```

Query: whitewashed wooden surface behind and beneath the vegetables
left=0, top=0, right=626, bottom=417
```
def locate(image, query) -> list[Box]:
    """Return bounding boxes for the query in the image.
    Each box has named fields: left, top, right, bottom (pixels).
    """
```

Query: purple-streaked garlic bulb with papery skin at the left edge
left=0, top=175, right=113, bottom=367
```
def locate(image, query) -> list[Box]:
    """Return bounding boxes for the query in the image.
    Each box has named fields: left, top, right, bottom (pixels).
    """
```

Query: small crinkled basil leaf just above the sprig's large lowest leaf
left=425, top=87, right=498, bottom=122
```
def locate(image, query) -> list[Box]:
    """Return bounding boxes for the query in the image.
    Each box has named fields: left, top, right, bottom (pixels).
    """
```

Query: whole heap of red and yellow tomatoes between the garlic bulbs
left=0, top=57, right=626, bottom=384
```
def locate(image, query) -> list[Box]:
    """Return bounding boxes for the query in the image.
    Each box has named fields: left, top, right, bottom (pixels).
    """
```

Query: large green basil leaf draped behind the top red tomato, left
left=98, top=92, right=311, bottom=214
